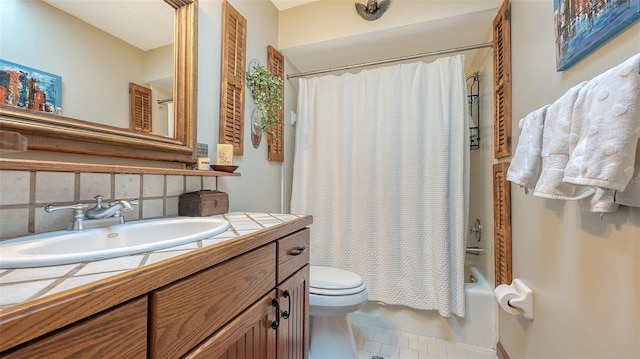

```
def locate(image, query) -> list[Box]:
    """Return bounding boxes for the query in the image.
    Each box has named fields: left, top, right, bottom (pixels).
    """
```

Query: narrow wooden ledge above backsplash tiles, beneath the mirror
left=0, top=158, right=240, bottom=177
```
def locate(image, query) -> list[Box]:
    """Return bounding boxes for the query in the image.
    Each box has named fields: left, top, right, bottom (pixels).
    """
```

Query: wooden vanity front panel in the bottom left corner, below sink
left=0, top=296, right=147, bottom=359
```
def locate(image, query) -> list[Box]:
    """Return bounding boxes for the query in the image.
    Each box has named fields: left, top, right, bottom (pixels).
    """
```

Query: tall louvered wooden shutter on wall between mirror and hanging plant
left=219, top=1, right=247, bottom=156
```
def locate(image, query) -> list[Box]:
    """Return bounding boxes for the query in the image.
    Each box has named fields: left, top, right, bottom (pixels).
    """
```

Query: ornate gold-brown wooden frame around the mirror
left=0, top=0, right=198, bottom=164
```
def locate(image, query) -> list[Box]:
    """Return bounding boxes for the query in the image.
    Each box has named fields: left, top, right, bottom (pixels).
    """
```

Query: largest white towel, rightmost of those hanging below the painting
left=563, top=54, right=640, bottom=191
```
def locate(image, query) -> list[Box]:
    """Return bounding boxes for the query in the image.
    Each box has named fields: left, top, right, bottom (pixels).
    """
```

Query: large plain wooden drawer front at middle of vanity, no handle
left=149, top=243, right=276, bottom=358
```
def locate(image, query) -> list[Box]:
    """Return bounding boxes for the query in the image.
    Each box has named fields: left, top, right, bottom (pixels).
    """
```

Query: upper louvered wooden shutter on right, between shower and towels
left=493, top=0, right=511, bottom=158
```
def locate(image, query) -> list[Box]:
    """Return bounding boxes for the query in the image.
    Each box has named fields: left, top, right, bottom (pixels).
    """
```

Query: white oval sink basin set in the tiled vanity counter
left=0, top=217, right=229, bottom=269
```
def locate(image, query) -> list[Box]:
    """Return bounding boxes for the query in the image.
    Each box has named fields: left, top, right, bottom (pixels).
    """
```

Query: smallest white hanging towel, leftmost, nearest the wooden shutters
left=507, top=105, right=549, bottom=188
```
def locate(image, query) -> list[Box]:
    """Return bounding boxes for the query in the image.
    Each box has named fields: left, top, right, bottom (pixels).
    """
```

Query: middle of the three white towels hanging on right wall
left=533, top=81, right=595, bottom=200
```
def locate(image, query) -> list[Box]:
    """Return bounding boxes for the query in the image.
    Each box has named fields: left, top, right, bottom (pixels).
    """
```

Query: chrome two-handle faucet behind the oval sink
left=44, top=195, right=139, bottom=231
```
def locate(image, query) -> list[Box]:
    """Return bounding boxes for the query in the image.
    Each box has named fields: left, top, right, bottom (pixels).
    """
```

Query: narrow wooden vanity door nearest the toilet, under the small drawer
left=277, top=265, right=309, bottom=359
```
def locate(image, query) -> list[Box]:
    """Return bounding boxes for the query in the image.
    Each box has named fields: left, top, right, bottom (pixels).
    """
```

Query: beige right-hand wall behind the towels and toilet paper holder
left=500, top=0, right=640, bottom=359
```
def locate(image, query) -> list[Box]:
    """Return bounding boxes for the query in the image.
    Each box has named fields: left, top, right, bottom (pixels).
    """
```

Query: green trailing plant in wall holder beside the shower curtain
left=247, top=65, right=282, bottom=140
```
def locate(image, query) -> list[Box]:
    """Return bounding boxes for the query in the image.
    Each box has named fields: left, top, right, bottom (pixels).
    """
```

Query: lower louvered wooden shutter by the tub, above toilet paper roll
left=493, top=162, right=512, bottom=287
